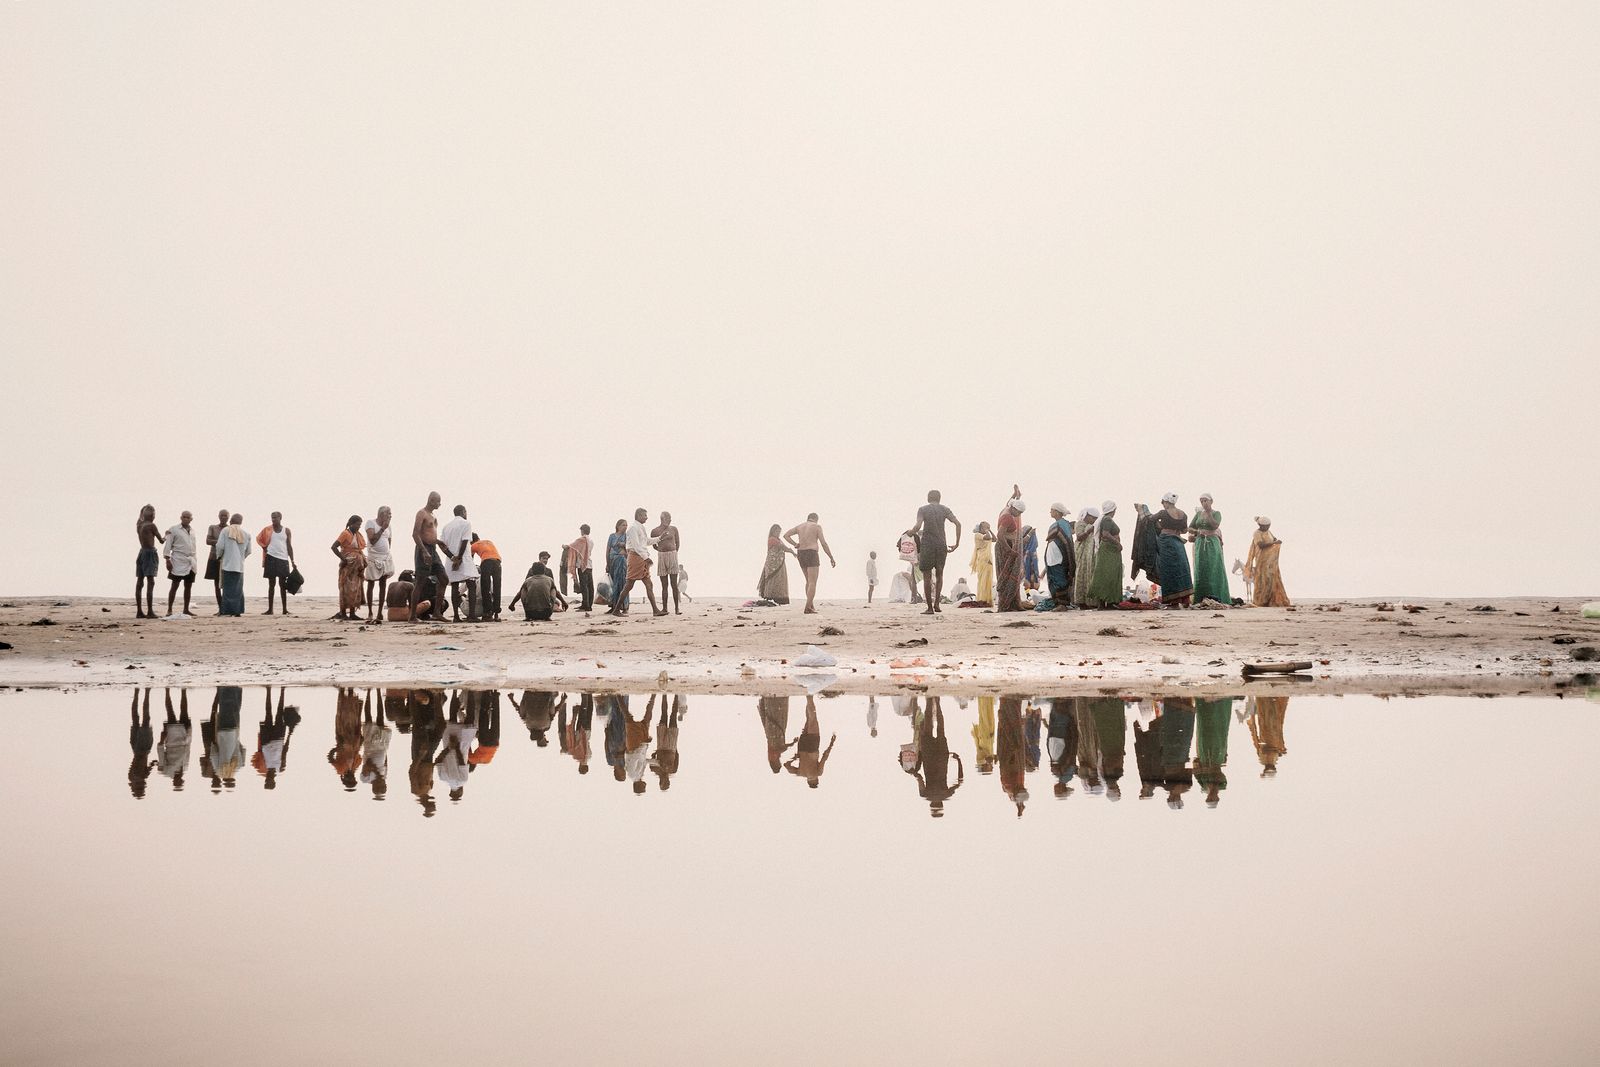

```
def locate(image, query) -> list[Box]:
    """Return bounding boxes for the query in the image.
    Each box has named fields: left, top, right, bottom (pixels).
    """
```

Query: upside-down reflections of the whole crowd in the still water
left=128, top=686, right=1288, bottom=817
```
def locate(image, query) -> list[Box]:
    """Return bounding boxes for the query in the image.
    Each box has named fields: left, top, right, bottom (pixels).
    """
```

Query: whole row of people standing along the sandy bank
left=134, top=486, right=1290, bottom=624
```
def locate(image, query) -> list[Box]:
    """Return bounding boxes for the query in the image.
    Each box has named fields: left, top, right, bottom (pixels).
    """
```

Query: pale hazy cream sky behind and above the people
left=0, top=0, right=1600, bottom=597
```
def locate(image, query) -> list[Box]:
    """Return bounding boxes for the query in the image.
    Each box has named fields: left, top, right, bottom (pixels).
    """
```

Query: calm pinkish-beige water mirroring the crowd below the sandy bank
left=0, top=688, right=1600, bottom=1064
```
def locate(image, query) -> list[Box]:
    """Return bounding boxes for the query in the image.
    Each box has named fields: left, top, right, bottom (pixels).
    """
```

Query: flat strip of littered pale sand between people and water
left=0, top=598, right=1600, bottom=696
